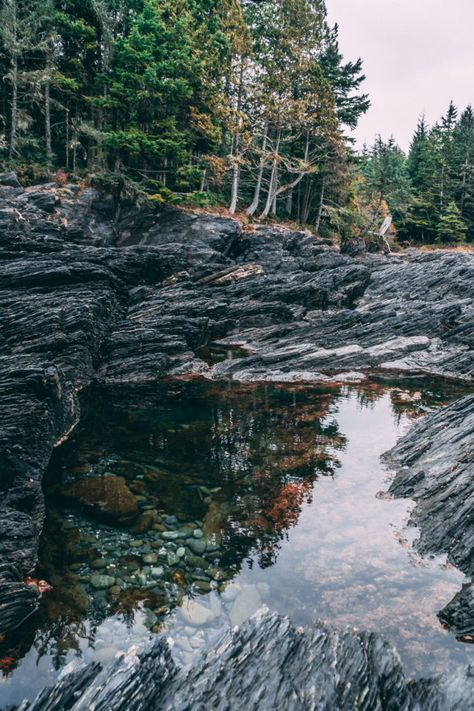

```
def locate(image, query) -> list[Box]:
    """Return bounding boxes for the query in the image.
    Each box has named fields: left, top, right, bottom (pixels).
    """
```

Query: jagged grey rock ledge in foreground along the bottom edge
left=12, top=611, right=474, bottom=711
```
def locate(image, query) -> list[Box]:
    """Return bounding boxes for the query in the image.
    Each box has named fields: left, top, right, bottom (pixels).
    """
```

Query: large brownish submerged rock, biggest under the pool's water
left=61, top=476, right=138, bottom=522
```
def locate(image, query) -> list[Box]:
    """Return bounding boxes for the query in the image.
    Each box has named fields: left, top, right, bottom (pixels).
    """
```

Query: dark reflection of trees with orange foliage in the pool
left=58, top=383, right=345, bottom=569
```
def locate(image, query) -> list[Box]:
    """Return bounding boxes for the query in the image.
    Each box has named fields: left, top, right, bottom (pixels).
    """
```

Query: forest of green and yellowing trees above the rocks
left=0, top=0, right=474, bottom=244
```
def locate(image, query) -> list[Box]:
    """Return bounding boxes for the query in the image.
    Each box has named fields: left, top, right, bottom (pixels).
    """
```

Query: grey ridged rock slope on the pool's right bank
left=386, top=395, right=474, bottom=641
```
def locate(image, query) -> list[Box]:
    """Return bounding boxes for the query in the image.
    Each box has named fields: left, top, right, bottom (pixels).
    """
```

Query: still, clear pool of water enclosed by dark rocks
left=0, top=381, right=472, bottom=705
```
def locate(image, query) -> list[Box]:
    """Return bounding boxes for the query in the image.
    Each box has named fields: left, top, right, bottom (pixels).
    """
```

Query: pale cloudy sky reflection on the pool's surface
left=0, top=390, right=472, bottom=705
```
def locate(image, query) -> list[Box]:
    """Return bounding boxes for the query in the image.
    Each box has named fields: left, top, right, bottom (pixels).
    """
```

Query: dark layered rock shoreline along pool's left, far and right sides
left=0, top=175, right=474, bottom=708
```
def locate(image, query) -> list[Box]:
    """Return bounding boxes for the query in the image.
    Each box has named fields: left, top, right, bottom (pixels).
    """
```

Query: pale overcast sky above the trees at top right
left=326, top=0, right=474, bottom=149
